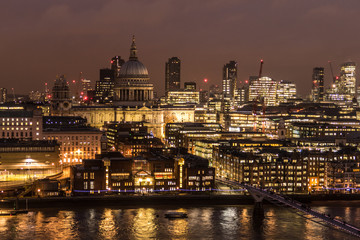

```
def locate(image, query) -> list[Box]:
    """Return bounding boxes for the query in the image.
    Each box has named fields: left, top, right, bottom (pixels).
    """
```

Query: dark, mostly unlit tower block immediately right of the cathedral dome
left=165, top=57, right=181, bottom=92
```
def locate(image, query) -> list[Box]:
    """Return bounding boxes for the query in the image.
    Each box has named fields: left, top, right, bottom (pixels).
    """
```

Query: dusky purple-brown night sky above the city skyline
left=0, top=0, right=360, bottom=95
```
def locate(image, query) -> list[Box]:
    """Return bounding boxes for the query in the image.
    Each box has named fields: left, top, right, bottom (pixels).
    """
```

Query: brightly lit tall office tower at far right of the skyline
left=340, top=62, right=356, bottom=100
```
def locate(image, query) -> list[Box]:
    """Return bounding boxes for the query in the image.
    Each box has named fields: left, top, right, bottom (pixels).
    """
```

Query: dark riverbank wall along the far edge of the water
left=0, top=194, right=360, bottom=209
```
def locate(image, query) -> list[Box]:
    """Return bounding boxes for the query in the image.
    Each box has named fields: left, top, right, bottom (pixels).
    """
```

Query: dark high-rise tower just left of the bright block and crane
left=223, top=61, right=237, bottom=99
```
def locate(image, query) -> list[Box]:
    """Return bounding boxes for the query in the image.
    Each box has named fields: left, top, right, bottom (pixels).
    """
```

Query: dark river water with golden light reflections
left=0, top=202, right=360, bottom=240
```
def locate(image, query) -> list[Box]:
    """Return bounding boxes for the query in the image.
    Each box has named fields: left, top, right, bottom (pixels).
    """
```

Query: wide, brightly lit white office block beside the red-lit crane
left=249, top=77, right=277, bottom=106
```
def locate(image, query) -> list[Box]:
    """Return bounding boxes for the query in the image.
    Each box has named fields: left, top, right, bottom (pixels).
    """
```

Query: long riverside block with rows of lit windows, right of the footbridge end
left=214, top=147, right=327, bottom=193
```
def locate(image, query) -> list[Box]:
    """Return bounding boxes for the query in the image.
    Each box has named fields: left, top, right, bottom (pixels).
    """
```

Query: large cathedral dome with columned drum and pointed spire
left=114, top=37, right=154, bottom=105
